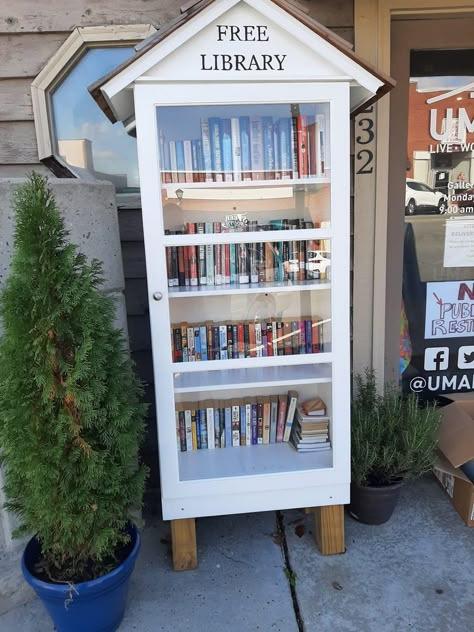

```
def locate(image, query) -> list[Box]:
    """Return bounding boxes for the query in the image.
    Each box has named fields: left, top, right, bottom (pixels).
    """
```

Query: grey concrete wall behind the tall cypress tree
left=0, top=178, right=127, bottom=554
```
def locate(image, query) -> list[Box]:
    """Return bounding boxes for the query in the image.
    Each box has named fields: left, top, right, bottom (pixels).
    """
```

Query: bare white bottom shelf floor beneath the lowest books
left=178, top=443, right=333, bottom=481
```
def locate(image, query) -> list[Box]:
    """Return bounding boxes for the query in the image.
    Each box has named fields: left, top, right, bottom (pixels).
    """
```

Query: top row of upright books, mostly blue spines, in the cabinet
left=159, top=114, right=326, bottom=183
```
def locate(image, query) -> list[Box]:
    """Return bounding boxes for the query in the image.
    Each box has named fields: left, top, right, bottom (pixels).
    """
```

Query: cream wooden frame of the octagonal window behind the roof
left=31, top=24, right=156, bottom=160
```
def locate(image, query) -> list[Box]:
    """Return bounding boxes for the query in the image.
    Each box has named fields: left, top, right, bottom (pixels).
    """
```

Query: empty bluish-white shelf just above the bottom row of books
left=174, top=360, right=332, bottom=393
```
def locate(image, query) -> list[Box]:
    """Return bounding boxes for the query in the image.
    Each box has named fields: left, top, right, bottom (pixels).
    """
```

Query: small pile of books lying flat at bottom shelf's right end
left=290, top=397, right=331, bottom=452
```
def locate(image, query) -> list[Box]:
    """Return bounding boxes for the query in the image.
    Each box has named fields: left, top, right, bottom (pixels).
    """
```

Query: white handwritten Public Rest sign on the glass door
left=425, top=281, right=474, bottom=339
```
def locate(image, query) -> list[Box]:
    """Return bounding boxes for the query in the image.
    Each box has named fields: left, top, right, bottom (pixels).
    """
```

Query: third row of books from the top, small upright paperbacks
left=171, top=316, right=324, bottom=362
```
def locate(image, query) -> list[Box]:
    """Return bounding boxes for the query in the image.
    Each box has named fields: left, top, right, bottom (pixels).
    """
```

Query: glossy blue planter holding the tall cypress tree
left=21, top=527, right=140, bottom=632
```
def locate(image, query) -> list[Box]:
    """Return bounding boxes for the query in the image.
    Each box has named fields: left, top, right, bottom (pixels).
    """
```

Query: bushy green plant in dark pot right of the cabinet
left=349, top=369, right=441, bottom=524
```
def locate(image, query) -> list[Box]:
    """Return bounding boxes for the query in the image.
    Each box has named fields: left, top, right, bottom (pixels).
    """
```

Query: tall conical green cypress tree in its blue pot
left=0, top=174, right=147, bottom=632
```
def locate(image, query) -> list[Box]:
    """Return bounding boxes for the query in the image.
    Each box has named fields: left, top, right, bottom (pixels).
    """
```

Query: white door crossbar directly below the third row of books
left=171, top=354, right=333, bottom=373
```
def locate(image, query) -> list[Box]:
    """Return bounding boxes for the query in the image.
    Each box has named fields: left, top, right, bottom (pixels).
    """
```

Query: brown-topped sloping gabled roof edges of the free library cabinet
left=89, top=0, right=396, bottom=123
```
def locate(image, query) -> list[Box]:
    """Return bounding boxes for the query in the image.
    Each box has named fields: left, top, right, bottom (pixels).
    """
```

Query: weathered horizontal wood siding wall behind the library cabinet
left=0, top=0, right=354, bottom=488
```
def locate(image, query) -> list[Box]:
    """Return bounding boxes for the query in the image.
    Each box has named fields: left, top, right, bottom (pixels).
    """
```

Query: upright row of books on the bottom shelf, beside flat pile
left=175, top=391, right=298, bottom=452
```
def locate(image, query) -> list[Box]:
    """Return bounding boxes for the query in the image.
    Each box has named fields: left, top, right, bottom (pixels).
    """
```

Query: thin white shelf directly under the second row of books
left=168, top=280, right=331, bottom=298
